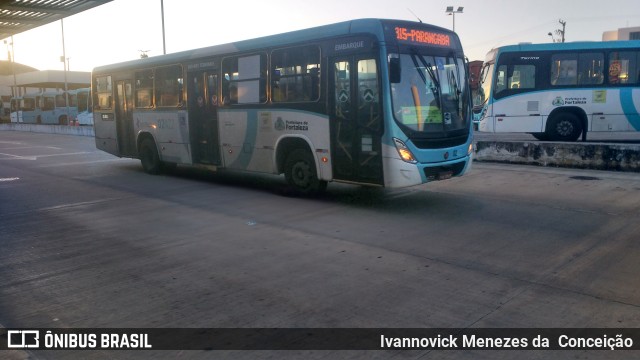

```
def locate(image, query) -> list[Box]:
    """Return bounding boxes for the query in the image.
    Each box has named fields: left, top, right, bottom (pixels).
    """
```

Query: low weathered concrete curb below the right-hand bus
left=475, top=141, right=640, bottom=172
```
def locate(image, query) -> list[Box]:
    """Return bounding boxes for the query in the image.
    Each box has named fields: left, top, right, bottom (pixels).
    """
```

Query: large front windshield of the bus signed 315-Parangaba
left=392, top=51, right=469, bottom=133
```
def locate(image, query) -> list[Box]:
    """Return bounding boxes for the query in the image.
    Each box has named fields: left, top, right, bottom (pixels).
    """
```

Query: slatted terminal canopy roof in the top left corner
left=0, top=0, right=111, bottom=39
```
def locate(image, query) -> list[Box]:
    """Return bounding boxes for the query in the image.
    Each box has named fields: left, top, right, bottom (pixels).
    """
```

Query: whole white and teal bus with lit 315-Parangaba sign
left=92, top=19, right=473, bottom=193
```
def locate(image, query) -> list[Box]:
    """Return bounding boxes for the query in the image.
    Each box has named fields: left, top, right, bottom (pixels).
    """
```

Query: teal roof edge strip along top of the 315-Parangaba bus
left=93, top=19, right=460, bottom=72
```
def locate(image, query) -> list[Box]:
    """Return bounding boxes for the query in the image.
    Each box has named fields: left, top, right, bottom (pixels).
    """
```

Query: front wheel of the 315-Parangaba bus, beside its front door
left=284, top=149, right=327, bottom=195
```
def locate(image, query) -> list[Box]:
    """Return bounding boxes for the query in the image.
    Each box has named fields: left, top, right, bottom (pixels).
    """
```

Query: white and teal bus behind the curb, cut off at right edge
left=474, top=40, right=640, bottom=141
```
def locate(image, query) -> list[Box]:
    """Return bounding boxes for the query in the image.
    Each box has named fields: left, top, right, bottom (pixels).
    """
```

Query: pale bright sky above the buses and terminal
left=5, top=0, right=640, bottom=71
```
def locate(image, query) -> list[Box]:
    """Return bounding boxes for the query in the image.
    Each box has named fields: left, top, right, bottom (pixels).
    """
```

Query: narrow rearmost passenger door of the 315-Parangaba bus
left=115, top=80, right=138, bottom=156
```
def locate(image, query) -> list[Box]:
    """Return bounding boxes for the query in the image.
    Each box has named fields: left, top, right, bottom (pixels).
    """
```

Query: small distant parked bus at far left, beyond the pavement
left=11, top=91, right=78, bottom=125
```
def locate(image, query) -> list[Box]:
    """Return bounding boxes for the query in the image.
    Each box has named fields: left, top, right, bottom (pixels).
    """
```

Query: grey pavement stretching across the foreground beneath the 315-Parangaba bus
left=0, top=131, right=640, bottom=359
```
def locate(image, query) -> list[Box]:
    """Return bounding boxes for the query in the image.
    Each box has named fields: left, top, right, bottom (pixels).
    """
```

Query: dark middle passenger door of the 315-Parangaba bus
left=187, top=71, right=220, bottom=165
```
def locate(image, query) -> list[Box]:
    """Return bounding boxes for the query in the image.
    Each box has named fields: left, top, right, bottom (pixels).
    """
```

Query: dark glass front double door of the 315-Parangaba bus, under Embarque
left=329, top=57, right=384, bottom=185
